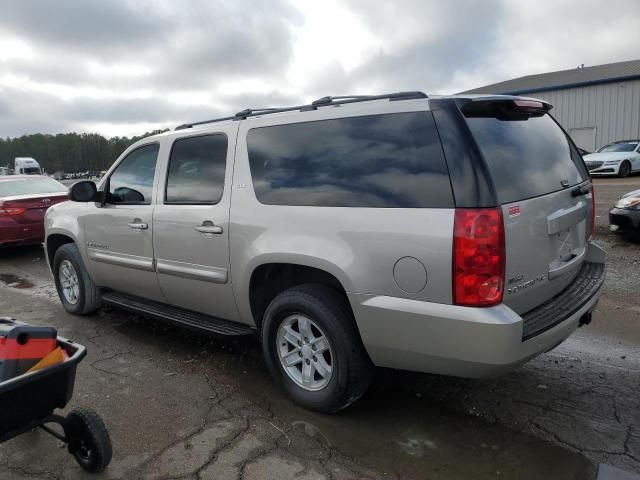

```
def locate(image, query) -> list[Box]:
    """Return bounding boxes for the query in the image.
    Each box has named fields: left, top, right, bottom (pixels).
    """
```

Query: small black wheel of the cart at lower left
left=65, top=408, right=111, bottom=472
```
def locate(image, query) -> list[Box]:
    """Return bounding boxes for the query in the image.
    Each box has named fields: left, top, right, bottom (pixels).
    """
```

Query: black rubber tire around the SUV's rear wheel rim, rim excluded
left=262, top=284, right=374, bottom=413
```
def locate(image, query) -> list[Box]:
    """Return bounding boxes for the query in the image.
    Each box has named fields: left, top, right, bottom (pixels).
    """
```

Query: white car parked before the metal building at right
left=583, top=140, right=640, bottom=177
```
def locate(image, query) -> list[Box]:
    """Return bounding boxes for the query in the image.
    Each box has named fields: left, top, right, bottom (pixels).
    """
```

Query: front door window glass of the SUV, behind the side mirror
left=108, top=143, right=160, bottom=205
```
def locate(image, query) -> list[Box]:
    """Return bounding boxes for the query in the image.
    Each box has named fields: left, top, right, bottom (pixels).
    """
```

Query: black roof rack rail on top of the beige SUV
left=175, top=91, right=428, bottom=130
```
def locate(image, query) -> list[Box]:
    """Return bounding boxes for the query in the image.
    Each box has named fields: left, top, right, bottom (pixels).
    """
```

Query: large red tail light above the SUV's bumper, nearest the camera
left=453, top=208, right=505, bottom=307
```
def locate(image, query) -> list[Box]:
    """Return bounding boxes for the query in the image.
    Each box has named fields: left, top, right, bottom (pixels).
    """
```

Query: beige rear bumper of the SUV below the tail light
left=349, top=244, right=605, bottom=378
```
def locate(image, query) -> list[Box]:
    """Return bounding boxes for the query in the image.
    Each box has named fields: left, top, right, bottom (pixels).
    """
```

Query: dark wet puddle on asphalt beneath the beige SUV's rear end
left=249, top=378, right=593, bottom=480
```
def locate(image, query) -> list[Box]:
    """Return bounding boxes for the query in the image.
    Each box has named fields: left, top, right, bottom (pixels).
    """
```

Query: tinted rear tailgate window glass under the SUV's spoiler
left=467, top=115, right=587, bottom=203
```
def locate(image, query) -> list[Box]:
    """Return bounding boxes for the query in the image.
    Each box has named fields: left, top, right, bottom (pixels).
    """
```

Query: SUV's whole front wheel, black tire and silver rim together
left=53, top=243, right=102, bottom=315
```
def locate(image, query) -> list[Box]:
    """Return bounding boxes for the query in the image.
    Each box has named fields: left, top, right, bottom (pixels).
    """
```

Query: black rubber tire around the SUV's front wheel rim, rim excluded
left=53, top=243, right=102, bottom=315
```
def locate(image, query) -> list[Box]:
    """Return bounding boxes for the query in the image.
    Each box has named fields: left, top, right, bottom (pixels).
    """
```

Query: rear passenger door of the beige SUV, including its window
left=153, top=125, right=237, bottom=320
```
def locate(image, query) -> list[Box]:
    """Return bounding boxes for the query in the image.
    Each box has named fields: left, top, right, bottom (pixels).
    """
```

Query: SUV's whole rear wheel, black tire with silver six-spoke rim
left=262, top=284, right=373, bottom=413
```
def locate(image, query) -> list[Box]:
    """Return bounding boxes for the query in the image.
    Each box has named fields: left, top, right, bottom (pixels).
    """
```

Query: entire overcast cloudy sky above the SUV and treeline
left=0, top=0, right=640, bottom=137
